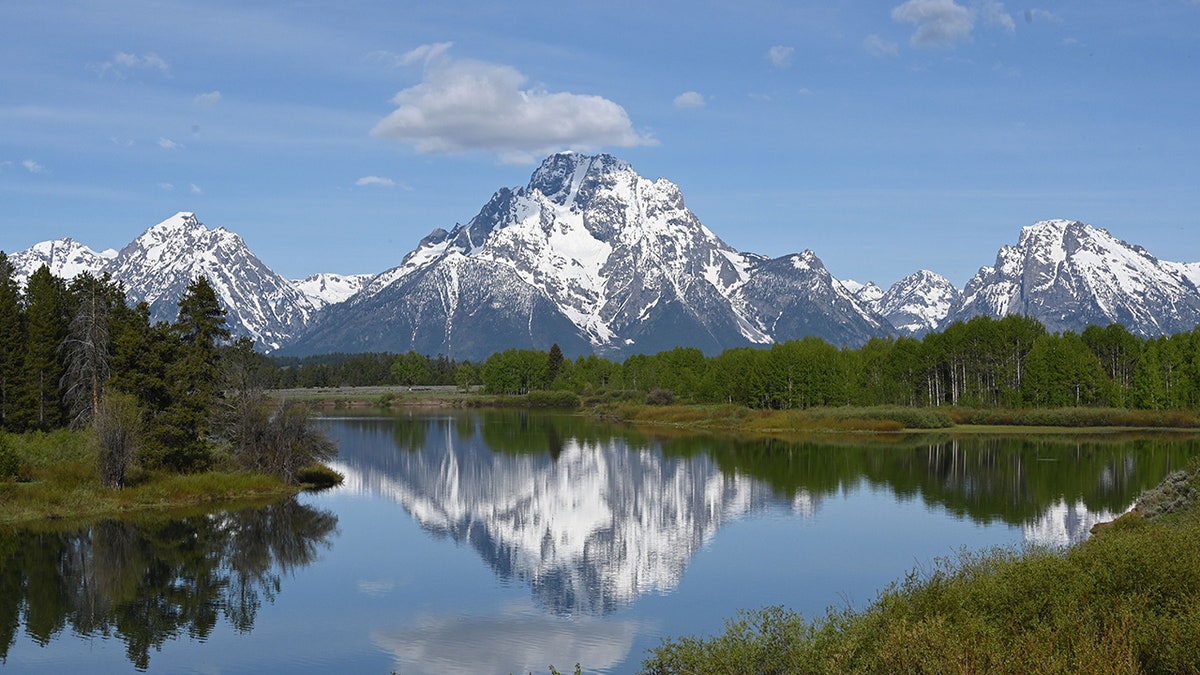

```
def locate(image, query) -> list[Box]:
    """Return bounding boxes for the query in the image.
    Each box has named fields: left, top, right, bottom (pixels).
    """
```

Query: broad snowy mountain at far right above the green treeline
left=949, top=220, right=1200, bottom=336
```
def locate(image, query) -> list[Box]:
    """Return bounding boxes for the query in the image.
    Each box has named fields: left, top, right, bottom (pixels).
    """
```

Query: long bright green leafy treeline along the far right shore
left=470, top=316, right=1200, bottom=410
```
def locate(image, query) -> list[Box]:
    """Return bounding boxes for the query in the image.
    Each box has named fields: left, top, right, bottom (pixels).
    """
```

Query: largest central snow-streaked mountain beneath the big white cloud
left=288, top=153, right=888, bottom=358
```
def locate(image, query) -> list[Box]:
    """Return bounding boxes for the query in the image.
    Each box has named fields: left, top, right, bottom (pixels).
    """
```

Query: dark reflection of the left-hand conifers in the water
left=0, top=498, right=337, bottom=670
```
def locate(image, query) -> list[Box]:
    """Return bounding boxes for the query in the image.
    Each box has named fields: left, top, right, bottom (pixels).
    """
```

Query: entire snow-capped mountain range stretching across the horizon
left=10, top=153, right=1200, bottom=359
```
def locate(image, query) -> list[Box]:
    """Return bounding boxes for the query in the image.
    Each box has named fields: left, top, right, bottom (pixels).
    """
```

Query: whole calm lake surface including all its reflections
left=0, top=412, right=1200, bottom=674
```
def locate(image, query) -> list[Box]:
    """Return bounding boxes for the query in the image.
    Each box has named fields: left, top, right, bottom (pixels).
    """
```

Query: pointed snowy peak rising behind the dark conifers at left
left=104, top=211, right=316, bottom=351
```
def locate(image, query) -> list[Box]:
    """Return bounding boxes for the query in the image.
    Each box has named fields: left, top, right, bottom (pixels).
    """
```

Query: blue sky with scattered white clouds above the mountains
left=0, top=0, right=1200, bottom=287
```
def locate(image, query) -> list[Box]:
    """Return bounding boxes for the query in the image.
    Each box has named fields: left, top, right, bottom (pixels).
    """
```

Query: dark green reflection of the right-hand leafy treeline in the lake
left=662, top=436, right=1200, bottom=525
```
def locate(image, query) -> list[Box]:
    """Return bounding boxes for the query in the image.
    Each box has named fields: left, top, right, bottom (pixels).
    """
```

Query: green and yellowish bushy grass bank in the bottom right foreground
left=643, top=467, right=1200, bottom=675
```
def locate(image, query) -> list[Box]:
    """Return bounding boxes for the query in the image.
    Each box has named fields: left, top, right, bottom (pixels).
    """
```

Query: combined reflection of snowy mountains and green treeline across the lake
left=331, top=412, right=1195, bottom=614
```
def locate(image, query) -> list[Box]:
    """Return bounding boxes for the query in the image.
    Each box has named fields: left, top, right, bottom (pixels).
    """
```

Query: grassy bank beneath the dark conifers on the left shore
left=0, top=431, right=299, bottom=525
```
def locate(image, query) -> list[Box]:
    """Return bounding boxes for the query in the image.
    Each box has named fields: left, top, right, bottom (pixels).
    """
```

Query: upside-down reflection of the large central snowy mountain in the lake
left=335, top=419, right=796, bottom=614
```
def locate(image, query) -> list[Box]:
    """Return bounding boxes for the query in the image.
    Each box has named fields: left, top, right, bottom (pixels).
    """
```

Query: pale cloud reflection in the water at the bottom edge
left=371, top=613, right=641, bottom=675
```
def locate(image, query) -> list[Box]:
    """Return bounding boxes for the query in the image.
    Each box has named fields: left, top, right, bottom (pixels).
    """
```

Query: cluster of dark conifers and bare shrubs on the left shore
left=0, top=252, right=334, bottom=486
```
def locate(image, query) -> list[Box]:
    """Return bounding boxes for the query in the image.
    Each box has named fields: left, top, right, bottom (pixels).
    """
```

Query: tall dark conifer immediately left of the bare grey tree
left=19, top=265, right=67, bottom=430
